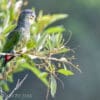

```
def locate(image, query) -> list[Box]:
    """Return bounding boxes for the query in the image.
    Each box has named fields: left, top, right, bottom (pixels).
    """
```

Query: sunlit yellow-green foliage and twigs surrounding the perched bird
left=0, top=0, right=78, bottom=97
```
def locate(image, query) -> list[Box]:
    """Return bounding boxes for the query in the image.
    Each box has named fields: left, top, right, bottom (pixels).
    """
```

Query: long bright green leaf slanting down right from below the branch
left=17, top=54, right=49, bottom=87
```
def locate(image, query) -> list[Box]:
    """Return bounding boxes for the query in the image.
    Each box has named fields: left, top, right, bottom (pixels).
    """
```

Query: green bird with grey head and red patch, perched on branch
left=0, top=9, right=36, bottom=71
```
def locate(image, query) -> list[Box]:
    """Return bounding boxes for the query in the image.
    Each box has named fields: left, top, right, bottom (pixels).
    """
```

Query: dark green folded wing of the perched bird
left=3, top=30, right=20, bottom=52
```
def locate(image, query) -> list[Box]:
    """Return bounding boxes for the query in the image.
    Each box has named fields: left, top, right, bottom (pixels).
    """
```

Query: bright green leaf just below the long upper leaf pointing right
left=44, top=26, right=65, bottom=34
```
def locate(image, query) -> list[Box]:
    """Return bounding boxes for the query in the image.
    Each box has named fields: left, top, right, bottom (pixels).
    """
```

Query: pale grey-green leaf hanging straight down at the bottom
left=50, top=75, right=57, bottom=97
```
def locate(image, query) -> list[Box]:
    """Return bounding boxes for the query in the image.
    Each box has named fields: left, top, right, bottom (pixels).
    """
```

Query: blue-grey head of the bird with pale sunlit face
left=18, top=9, right=36, bottom=25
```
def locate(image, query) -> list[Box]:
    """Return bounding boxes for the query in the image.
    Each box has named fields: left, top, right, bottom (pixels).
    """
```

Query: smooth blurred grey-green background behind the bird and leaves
left=11, top=0, right=100, bottom=100
